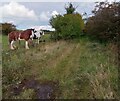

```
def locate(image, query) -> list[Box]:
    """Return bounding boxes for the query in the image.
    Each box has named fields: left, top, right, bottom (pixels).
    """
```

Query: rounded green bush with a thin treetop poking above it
left=50, top=4, right=84, bottom=39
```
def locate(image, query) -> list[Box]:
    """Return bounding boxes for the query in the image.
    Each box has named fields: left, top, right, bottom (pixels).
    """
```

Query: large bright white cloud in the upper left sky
left=0, top=2, right=37, bottom=20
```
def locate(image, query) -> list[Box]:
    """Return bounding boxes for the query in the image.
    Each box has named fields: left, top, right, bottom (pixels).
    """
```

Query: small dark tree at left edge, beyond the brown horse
left=0, top=23, right=16, bottom=35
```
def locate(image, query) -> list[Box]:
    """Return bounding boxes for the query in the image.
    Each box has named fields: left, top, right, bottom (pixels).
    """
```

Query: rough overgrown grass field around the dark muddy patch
left=2, top=35, right=119, bottom=99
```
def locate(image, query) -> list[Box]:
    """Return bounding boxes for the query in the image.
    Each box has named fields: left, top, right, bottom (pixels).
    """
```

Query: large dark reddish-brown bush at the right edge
left=86, top=2, right=120, bottom=41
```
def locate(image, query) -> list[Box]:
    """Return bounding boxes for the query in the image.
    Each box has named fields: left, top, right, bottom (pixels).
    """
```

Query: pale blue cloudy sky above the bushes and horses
left=0, top=0, right=119, bottom=29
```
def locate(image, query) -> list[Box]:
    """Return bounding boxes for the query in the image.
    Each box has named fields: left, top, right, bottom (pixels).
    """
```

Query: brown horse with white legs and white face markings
left=8, top=29, right=34, bottom=50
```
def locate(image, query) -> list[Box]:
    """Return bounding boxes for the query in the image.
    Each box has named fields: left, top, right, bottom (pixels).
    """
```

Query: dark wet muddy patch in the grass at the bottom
left=11, top=77, right=59, bottom=99
